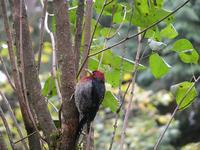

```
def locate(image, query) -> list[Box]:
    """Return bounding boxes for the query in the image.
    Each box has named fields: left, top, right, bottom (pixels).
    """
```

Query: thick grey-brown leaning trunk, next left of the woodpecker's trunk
left=14, top=0, right=57, bottom=145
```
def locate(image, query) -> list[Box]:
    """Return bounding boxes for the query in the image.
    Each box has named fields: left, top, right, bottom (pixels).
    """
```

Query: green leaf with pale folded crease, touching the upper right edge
left=173, top=39, right=199, bottom=64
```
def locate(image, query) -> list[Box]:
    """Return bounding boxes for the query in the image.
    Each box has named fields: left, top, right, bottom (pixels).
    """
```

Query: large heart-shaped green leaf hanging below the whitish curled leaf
left=149, top=53, right=171, bottom=79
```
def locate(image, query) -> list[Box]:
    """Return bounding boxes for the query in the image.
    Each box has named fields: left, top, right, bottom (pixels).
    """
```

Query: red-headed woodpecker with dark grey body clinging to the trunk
left=74, top=70, right=105, bottom=140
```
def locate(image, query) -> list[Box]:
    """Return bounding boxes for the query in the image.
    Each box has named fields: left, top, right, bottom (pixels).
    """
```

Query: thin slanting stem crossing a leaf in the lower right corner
left=153, top=76, right=200, bottom=150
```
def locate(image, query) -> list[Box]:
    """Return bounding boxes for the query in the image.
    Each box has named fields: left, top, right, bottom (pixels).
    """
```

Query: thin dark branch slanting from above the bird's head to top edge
left=76, top=0, right=112, bottom=78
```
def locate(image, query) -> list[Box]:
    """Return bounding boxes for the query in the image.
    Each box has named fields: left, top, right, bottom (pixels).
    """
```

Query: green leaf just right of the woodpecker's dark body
left=102, top=91, right=119, bottom=112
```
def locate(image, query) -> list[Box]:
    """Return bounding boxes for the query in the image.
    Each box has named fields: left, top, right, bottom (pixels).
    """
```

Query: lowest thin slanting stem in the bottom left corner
left=0, top=107, right=16, bottom=150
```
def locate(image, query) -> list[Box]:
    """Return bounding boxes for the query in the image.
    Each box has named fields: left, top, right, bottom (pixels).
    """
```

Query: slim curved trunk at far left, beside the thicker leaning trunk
left=1, top=0, right=41, bottom=150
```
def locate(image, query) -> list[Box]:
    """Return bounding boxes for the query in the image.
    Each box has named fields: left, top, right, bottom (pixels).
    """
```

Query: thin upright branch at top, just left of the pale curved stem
left=37, top=0, right=48, bottom=73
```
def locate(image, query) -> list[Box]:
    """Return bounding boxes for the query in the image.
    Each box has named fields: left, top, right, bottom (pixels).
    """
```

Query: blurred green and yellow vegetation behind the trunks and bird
left=0, top=0, right=200, bottom=150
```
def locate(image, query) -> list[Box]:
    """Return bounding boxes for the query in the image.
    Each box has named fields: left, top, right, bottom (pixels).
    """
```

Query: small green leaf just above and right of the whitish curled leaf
left=160, top=24, right=178, bottom=39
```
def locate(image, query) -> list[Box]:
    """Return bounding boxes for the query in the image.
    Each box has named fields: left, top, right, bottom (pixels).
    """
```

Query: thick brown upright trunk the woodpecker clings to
left=54, top=0, right=78, bottom=150
